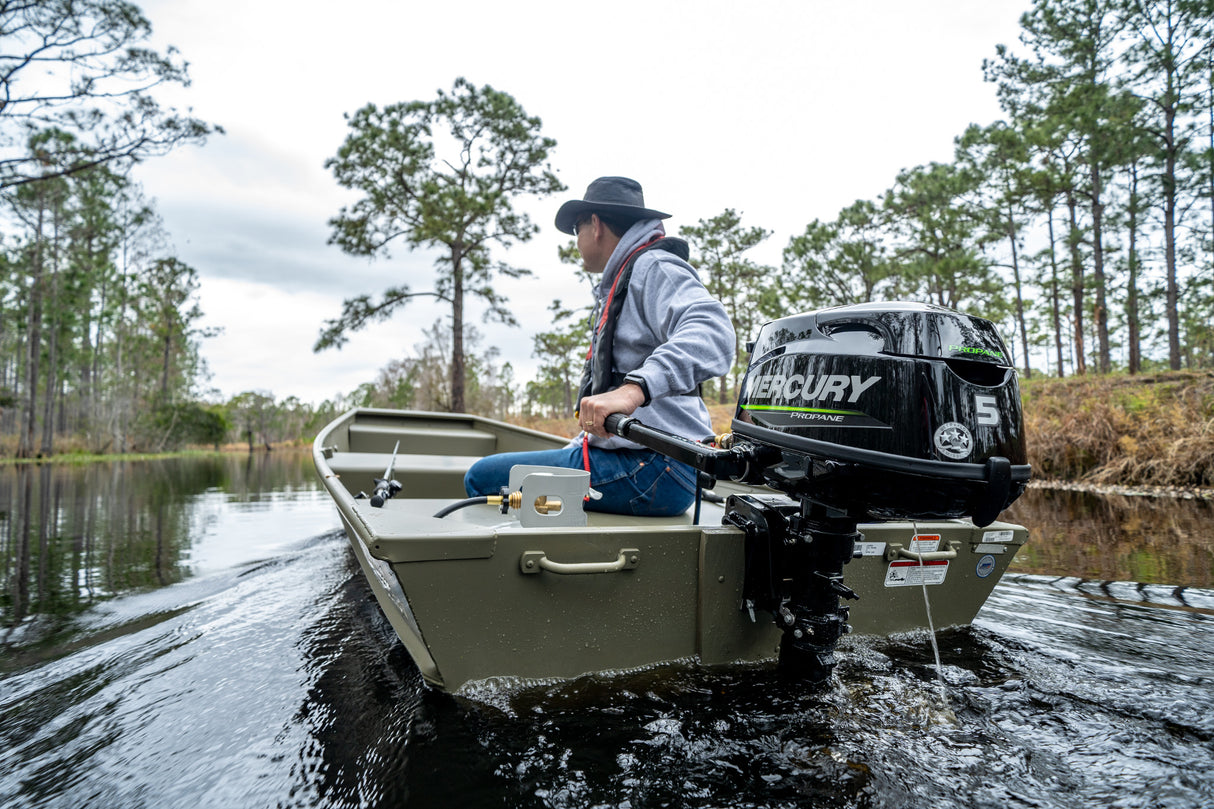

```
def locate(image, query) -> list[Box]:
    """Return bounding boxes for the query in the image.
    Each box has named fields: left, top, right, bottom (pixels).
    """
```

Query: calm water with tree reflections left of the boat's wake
left=0, top=452, right=327, bottom=671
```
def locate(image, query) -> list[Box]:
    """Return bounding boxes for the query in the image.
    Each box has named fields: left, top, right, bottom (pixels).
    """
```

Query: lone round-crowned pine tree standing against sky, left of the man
left=314, top=79, right=565, bottom=412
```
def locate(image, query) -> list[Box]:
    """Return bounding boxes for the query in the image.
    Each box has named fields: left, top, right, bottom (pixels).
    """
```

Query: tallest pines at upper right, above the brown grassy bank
left=985, top=0, right=1214, bottom=373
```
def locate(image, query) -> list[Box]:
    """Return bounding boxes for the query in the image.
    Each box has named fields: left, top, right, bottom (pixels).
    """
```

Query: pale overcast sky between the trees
left=136, top=0, right=1029, bottom=403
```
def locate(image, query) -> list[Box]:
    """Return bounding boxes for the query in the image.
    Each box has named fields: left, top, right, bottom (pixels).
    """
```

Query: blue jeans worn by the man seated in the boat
left=464, top=447, right=696, bottom=516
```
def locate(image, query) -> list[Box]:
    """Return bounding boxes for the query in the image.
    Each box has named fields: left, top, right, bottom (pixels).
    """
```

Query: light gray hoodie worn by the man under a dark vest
left=569, top=219, right=734, bottom=449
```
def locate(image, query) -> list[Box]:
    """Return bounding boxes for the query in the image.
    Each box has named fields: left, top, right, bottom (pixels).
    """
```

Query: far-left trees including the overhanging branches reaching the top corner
left=0, top=0, right=222, bottom=457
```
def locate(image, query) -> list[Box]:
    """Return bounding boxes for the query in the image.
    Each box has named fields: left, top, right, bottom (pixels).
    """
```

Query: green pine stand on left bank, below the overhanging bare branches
left=0, top=147, right=203, bottom=457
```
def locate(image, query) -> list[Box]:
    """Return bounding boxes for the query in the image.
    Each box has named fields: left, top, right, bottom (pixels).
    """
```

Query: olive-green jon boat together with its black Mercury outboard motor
left=313, top=302, right=1032, bottom=690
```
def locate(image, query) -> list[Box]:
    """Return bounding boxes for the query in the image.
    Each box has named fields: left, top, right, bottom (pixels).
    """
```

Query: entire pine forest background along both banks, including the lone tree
left=0, top=0, right=1214, bottom=485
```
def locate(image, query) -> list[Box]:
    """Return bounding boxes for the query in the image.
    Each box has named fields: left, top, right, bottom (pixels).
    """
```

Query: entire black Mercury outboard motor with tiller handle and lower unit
left=608, top=302, right=1029, bottom=681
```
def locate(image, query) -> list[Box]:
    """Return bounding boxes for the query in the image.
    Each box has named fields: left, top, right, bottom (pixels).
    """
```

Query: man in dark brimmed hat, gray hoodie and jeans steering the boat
left=464, top=177, right=734, bottom=516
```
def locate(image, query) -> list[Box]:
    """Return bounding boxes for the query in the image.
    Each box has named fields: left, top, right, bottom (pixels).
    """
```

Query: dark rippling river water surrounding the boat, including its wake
left=0, top=453, right=1214, bottom=809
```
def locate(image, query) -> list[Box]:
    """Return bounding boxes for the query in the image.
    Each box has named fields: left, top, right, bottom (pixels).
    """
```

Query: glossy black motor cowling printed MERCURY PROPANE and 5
left=733, top=302, right=1029, bottom=525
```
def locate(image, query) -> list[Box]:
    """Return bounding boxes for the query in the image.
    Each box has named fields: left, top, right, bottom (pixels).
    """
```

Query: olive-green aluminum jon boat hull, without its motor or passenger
left=312, top=409, right=1027, bottom=691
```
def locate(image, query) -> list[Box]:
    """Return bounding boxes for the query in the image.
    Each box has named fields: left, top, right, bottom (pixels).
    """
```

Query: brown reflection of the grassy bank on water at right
left=1004, top=488, right=1214, bottom=588
